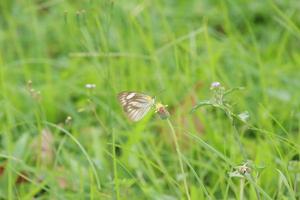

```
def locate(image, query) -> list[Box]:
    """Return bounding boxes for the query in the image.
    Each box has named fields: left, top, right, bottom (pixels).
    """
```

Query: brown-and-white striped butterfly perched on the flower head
left=118, top=92, right=155, bottom=122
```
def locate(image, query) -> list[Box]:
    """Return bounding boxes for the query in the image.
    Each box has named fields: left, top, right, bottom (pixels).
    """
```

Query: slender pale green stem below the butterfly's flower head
left=167, top=119, right=191, bottom=200
